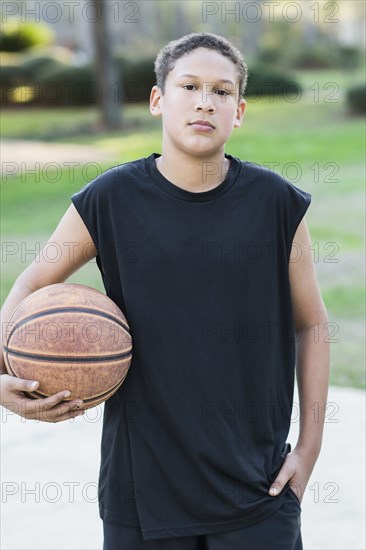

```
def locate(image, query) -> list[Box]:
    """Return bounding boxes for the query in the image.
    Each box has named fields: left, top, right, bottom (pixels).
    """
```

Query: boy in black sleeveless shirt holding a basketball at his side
left=1, top=33, right=329, bottom=550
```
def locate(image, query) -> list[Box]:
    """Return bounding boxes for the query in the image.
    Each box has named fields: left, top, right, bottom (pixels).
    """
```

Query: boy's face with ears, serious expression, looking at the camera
left=150, top=48, right=245, bottom=156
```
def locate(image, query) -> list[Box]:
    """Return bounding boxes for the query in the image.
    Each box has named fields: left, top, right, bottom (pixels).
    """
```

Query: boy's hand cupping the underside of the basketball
left=0, top=374, right=84, bottom=422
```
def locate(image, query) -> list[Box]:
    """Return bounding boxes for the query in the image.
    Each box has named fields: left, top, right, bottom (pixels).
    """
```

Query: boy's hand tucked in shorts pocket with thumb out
left=268, top=448, right=316, bottom=504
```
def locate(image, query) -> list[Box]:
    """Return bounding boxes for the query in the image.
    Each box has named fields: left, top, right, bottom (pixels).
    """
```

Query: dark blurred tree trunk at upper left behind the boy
left=91, top=0, right=122, bottom=130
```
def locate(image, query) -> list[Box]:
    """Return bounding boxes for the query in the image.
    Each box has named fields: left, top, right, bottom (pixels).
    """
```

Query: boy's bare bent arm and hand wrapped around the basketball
left=0, top=205, right=97, bottom=421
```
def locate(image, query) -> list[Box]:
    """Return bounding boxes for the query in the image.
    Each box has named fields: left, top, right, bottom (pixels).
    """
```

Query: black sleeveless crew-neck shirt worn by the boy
left=72, top=153, right=311, bottom=540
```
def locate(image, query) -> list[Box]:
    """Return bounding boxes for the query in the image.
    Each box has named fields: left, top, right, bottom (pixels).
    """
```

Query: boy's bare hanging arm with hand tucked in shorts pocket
left=270, top=219, right=330, bottom=501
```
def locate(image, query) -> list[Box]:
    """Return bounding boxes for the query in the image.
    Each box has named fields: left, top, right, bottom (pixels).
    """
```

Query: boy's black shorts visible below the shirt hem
left=103, top=490, right=302, bottom=550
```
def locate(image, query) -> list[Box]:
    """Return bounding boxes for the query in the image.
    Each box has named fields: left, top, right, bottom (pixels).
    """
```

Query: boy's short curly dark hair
left=154, top=32, right=248, bottom=99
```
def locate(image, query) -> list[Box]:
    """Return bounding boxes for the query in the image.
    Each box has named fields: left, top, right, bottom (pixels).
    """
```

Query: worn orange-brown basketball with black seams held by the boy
left=4, top=283, right=132, bottom=409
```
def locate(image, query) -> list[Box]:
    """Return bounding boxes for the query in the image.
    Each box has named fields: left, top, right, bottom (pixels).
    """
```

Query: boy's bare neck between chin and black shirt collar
left=155, top=151, right=230, bottom=193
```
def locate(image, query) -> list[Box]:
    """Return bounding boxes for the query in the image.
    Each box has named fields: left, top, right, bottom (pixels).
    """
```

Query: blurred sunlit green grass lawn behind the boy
left=1, top=73, right=365, bottom=387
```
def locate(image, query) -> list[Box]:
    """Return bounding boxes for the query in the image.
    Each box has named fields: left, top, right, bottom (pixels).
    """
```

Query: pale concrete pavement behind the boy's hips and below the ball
left=0, top=387, right=366, bottom=550
